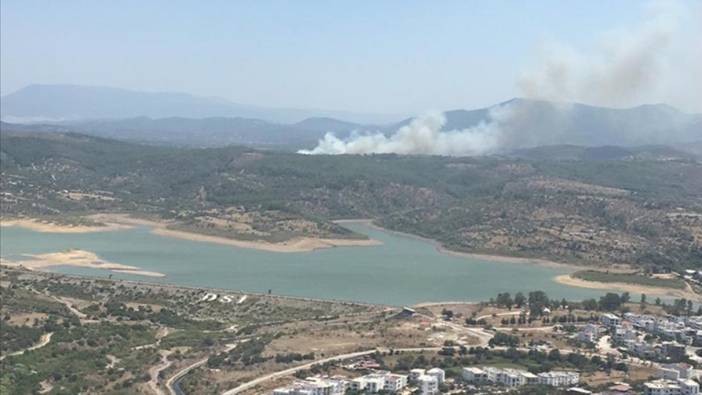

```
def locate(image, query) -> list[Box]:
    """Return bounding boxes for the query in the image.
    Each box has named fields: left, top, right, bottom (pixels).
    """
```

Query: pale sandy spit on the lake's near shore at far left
left=0, top=250, right=165, bottom=277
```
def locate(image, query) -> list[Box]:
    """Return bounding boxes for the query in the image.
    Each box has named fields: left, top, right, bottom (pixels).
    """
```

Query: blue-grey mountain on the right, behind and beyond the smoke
left=388, top=98, right=702, bottom=148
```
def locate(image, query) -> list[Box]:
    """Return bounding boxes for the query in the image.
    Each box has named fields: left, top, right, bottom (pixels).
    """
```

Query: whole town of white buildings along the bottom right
left=272, top=306, right=702, bottom=395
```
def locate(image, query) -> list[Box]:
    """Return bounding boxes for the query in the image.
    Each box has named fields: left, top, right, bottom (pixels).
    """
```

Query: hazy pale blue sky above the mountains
left=0, top=0, right=702, bottom=113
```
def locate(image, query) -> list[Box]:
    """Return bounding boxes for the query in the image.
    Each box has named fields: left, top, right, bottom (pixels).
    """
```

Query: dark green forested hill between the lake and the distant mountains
left=0, top=132, right=702, bottom=268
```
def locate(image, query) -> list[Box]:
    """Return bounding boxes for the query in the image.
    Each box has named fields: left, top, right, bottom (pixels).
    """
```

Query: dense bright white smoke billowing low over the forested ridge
left=298, top=107, right=509, bottom=156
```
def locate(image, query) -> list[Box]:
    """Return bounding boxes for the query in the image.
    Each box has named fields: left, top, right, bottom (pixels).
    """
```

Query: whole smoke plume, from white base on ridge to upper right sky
left=299, top=1, right=702, bottom=156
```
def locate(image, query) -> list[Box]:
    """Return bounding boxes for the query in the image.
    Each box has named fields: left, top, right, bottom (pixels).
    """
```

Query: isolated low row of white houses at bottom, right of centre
left=461, top=367, right=580, bottom=387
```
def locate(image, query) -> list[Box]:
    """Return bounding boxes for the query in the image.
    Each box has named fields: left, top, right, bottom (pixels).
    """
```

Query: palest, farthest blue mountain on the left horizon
left=0, top=85, right=396, bottom=123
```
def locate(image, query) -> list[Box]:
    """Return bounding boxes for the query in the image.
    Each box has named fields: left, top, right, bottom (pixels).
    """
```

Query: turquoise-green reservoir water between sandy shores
left=0, top=223, right=604, bottom=305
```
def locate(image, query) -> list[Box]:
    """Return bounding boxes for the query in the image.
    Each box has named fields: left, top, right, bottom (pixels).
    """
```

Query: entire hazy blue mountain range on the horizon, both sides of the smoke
left=2, top=89, right=702, bottom=152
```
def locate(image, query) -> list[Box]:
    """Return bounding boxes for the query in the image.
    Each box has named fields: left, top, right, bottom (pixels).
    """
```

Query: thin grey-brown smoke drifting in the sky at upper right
left=517, top=1, right=702, bottom=107
